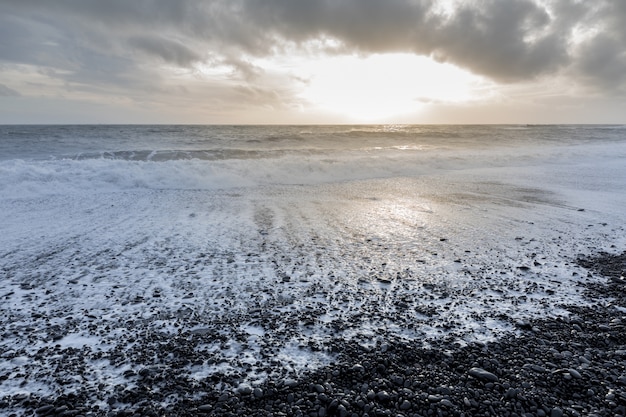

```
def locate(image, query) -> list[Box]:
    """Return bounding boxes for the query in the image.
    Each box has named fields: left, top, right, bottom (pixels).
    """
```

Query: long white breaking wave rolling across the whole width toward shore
left=0, top=140, right=626, bottom=198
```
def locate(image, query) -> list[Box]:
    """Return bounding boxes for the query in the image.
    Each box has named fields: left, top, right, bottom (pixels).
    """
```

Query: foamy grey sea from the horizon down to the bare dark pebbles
left=0, top=125, right=626, bottom=400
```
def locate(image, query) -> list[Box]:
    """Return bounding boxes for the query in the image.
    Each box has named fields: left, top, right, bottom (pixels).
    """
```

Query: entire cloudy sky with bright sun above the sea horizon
left=0, top=0, right=626, bottom=124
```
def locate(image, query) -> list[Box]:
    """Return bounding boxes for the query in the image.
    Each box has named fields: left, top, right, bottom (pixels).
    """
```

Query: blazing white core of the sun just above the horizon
left=294, top=54, right=484, bottom=122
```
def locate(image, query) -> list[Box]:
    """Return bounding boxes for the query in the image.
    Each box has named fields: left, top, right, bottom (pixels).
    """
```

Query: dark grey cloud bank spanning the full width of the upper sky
left=0, top=0, right=626, bottom=92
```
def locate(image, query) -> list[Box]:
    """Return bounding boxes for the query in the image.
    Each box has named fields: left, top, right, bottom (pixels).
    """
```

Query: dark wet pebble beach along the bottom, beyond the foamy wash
left=0, top=252, right=626, bottom=417
